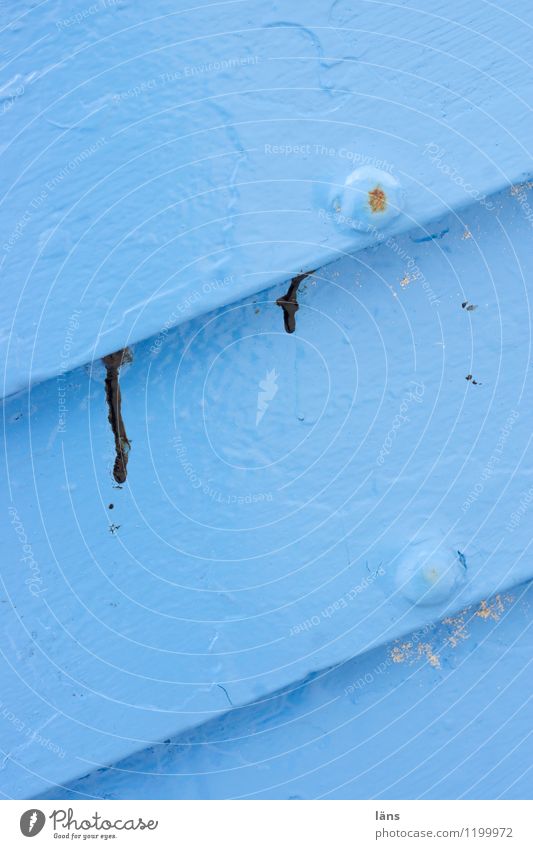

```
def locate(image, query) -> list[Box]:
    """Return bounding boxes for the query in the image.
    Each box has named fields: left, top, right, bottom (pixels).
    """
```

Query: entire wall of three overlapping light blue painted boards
left=0, top=0, right=533, bottom=797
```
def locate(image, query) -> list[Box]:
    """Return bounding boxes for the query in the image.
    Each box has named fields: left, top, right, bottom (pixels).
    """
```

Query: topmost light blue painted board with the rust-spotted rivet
left=0, top=0, right=533, bottom=394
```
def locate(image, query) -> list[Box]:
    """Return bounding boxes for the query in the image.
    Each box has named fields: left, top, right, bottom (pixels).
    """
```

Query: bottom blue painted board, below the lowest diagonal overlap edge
left=38, top=585, right=533, bottom=801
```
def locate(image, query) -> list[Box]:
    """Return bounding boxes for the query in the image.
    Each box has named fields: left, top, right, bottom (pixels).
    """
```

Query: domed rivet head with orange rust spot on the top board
left=332, top=165, right=403, bottom=232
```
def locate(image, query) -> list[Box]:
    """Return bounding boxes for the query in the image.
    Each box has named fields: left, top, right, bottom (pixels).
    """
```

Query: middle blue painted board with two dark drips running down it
left=1, top=179, right=533, bottom=795
